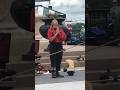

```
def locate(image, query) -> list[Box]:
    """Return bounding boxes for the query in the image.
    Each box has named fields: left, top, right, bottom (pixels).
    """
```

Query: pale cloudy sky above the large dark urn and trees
left=36, top=0, right=85, bottom=23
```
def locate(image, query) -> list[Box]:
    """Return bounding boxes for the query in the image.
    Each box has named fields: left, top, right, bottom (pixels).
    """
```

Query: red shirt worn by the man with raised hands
left=48, top=28, right=66, bottom=43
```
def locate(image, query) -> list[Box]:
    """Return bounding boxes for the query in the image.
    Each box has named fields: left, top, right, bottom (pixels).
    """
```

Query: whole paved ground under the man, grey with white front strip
left=35, top=68, right=85, bottom=90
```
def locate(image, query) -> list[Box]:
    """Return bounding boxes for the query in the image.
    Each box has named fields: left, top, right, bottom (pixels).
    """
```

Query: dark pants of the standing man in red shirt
left=49, top=42, right=63, bottom=71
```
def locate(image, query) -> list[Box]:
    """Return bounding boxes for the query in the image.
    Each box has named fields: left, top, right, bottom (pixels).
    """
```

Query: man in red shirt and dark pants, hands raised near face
left=48, top=19, right=66, bottom=78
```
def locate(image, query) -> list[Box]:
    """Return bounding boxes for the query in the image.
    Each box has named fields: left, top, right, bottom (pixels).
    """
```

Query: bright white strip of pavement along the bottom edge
left=35, top=81, right=85, bottom=90
